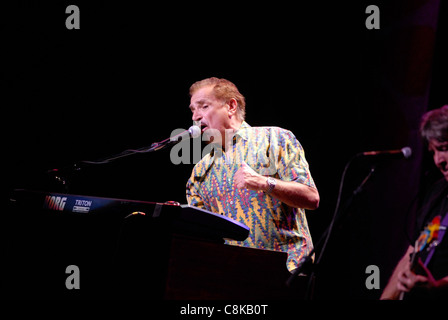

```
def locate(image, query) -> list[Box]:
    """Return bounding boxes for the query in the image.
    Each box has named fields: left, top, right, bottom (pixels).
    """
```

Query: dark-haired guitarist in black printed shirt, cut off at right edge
left=380, top=105, right=448, bottom=300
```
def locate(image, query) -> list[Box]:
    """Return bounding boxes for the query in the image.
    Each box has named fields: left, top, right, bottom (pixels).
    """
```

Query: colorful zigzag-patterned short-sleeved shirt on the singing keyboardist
left=186, top=122, right=315, bottom=271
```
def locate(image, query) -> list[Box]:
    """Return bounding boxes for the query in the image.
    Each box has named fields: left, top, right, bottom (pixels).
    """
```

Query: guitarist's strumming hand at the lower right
left=397, top=259, right=437, bottom=292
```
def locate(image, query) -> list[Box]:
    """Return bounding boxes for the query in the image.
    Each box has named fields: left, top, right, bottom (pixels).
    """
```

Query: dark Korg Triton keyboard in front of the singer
left=10, top=189, right=249, bottom=241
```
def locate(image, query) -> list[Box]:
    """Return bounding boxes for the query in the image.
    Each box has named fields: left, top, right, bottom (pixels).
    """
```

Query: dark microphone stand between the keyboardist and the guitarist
left=286, top=154, right=376, bottom=300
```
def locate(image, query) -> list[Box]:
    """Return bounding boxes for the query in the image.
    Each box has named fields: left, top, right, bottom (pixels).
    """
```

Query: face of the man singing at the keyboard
left=190, top=86, right=229, bottom=138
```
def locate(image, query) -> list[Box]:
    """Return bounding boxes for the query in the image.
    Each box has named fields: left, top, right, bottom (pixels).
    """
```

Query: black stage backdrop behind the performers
left=1, top=0, right=448, bottom=299
